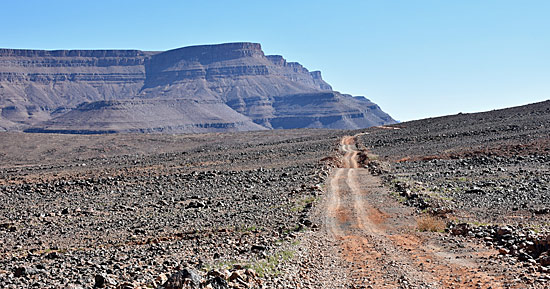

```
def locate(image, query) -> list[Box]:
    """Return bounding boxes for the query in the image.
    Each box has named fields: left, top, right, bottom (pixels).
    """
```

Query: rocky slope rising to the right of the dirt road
left=360, top=102, right=550, bottom=286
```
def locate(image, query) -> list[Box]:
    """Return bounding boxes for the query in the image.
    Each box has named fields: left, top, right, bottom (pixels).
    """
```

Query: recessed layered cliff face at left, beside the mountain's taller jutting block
left=0, top=49, right=149, bottom=130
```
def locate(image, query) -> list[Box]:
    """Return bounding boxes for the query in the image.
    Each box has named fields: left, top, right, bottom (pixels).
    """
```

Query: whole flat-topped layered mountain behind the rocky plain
left=0, top=43, right=395, bottom=133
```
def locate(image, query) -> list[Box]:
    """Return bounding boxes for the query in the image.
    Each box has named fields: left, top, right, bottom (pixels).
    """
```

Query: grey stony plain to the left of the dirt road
left=0, top=130, right=342, bottom=288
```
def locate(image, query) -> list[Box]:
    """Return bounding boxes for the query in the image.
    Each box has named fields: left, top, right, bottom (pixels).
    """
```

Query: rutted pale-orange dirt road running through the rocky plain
left=325, top=136, right=509, bottom=288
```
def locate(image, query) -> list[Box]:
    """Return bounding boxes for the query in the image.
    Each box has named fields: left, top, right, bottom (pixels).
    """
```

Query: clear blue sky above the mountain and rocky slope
left=0, top=0, right=550, bottom=121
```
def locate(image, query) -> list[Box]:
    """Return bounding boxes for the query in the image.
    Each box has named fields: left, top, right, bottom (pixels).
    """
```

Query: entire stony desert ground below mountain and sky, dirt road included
left=0, top=102, right=550, bottom=288
